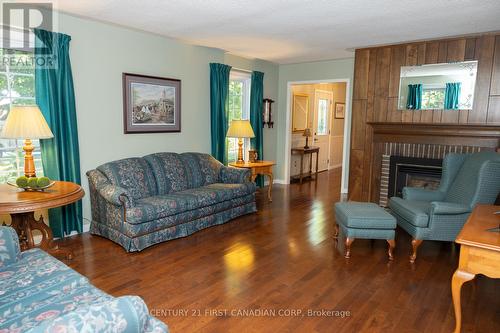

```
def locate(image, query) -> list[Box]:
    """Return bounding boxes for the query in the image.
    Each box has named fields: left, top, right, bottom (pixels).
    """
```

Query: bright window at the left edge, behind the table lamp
left=0, top=49, right=43, bottom=183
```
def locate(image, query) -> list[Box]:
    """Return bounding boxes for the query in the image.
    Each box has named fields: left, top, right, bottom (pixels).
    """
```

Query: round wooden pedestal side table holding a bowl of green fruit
left=0, top=181, right=85, bottom=259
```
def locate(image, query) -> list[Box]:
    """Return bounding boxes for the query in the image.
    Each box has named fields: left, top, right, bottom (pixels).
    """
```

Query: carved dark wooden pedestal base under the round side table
left=11, top=212, right=73, bottom=259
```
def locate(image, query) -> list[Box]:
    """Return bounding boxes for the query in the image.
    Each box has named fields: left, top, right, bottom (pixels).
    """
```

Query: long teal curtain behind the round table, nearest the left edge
left=34, top=29, right=83, bottom=237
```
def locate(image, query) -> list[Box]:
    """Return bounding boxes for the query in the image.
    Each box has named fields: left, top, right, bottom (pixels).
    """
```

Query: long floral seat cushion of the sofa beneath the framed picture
left=126, top=183, right=256, bottom=224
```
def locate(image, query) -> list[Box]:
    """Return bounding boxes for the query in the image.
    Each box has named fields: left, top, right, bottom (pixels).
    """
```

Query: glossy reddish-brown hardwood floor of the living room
left=56, top=169, right=500, bottom=333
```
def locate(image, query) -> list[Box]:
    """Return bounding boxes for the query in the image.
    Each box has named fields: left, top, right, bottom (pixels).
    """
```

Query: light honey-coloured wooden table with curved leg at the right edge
left=451, top=205, right=500, bottom=333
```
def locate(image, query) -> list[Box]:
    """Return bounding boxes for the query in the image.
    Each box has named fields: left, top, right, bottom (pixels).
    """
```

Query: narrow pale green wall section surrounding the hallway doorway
left=275, top=58, right=354, bottom=187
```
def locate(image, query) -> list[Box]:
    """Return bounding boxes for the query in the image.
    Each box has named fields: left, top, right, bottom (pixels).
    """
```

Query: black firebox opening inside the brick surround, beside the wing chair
left=387, top=156, right=443, bottom=198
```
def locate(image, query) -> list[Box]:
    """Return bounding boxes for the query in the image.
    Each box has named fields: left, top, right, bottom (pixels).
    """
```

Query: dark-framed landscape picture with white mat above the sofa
left=122, top=73, right=181, bottom=134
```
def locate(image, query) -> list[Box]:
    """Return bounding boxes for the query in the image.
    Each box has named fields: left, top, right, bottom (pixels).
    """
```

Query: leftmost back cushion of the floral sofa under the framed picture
left=97, top=157, right=157, bottom=199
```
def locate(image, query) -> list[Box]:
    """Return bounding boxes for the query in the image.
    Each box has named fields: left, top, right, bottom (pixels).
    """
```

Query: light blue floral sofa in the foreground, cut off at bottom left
left=0, top=226, right=168, bottom=333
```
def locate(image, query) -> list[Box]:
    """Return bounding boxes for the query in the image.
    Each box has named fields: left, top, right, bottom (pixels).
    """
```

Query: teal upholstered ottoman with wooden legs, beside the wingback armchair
left=335, top=202, right=396, bottom=260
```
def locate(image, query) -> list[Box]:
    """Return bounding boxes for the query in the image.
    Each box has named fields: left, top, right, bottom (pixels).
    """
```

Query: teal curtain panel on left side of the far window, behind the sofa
left=210, top=63, right=231, bottom=165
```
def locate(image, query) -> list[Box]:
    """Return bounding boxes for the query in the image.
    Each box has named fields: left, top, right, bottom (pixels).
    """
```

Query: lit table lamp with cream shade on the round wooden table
left=0, top=105, right=54, bottom=177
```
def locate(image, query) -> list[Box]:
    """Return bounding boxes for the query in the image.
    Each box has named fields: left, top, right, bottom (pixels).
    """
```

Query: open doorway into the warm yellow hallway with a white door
left=285, top=79, right=350, bottom=193
